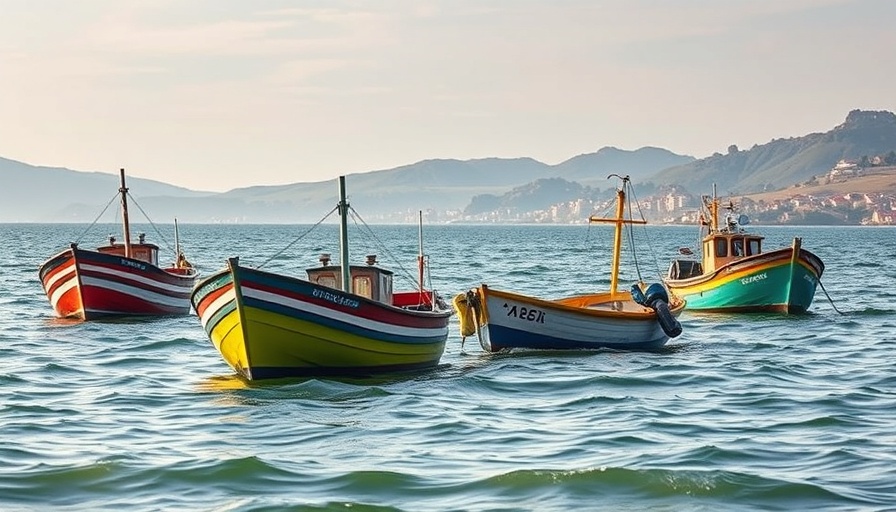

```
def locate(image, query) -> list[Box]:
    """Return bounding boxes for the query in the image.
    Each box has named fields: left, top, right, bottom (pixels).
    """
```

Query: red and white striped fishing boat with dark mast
left=39, top=169, right=199, bottom=320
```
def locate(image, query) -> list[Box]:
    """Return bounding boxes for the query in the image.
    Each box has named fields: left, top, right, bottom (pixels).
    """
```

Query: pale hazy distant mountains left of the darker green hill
left=0, top=148, right=693, bottom=223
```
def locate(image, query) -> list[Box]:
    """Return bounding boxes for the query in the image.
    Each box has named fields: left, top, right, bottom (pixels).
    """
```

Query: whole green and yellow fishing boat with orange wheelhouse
left=664, top=186, right=824, bottom=313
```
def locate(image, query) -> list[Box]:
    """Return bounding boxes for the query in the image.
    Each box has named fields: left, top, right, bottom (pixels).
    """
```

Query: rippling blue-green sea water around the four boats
left=0, top=224, right=896, bottom=511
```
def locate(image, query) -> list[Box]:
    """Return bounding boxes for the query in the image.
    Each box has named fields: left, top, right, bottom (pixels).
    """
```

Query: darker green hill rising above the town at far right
left=654, top=110, right=896, bottom=194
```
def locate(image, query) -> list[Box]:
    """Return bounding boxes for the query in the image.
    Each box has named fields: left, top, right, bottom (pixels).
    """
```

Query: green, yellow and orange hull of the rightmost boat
left=666, top=247, right=824, bottom=313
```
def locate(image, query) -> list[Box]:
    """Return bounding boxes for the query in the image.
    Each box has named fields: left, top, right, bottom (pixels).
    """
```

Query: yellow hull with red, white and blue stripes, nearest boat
left=192, top=261, right=451, bottom=380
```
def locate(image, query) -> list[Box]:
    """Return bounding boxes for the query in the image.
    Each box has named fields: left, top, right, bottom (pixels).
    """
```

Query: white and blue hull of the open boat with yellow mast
left=476, top=285, right=684, bottom=352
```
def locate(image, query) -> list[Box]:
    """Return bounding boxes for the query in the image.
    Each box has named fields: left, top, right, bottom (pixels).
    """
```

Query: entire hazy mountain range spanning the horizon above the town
left=7, top=110, right=896, bottom=223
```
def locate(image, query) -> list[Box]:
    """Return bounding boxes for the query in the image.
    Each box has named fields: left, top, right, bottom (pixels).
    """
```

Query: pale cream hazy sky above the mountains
left=0, top=0, right=896, bottom=191
